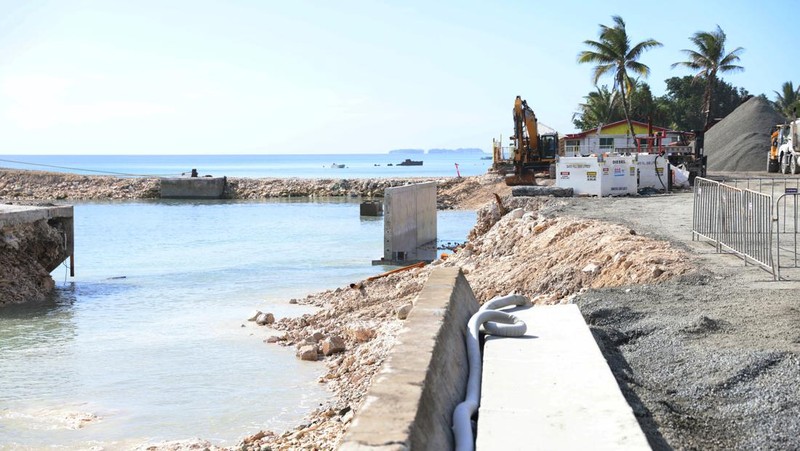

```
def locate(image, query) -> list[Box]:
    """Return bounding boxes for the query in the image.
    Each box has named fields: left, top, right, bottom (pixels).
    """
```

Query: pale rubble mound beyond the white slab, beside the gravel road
left=447, top=200, right=691, bottom=303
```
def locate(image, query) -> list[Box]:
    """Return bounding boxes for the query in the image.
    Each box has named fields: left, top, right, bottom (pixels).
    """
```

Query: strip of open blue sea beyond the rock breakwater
left=0, top=153, right=492, bottom=179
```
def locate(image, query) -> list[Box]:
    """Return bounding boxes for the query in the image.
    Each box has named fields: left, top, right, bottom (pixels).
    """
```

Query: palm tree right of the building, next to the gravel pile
left=672, top=25, right=744, bottom=129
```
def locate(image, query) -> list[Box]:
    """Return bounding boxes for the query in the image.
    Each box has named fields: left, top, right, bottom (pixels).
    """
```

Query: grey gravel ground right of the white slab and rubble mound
left=557, top=194, right=800, bottom=449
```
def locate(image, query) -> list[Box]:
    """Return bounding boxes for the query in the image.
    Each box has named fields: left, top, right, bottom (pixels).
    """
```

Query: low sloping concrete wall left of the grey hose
left=340, top=268, right=478, bottom=451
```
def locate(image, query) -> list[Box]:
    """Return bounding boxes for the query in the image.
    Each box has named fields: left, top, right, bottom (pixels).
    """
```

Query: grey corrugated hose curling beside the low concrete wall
left=453, top=294, right=531, bottom=451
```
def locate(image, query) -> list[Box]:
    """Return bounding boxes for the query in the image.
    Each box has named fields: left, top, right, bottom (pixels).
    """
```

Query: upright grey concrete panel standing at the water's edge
left=383, top=182, right=436, bottom=261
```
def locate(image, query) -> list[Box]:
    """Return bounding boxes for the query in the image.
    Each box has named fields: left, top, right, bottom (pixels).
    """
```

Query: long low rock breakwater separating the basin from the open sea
left=0, top=169, right=468, bottom=203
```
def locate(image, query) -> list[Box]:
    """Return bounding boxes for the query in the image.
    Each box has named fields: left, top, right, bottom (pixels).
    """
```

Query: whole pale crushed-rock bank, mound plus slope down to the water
left=241, top=196, right=691, bottom=450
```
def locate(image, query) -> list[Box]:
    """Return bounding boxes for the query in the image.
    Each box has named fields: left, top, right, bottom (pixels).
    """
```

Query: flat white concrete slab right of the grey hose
left=476, top=305, right=650, bottom=451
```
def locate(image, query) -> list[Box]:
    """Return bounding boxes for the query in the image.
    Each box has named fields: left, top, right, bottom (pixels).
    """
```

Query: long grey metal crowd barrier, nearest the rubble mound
left=692, top=177, right=780, bottom=280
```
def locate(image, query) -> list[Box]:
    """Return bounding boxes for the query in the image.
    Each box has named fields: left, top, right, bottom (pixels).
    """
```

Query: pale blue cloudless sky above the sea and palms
left=0, top=0, right=800, bottom=155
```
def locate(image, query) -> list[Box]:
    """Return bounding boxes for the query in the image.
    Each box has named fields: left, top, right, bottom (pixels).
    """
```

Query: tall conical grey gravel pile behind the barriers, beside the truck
left=705, top=97, right=784, bottom=172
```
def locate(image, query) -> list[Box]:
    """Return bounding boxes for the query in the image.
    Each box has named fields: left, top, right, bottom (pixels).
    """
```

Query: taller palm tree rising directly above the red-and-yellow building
left=578, top=16, right=661, bottom=137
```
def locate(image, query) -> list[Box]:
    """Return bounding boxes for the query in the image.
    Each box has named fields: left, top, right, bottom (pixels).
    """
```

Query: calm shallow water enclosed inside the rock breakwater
left=0, top=199, right=475, bottom=449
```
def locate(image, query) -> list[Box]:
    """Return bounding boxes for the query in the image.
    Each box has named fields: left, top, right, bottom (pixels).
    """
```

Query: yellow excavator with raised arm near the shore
left=505, top=96, right=558, bottom=186
